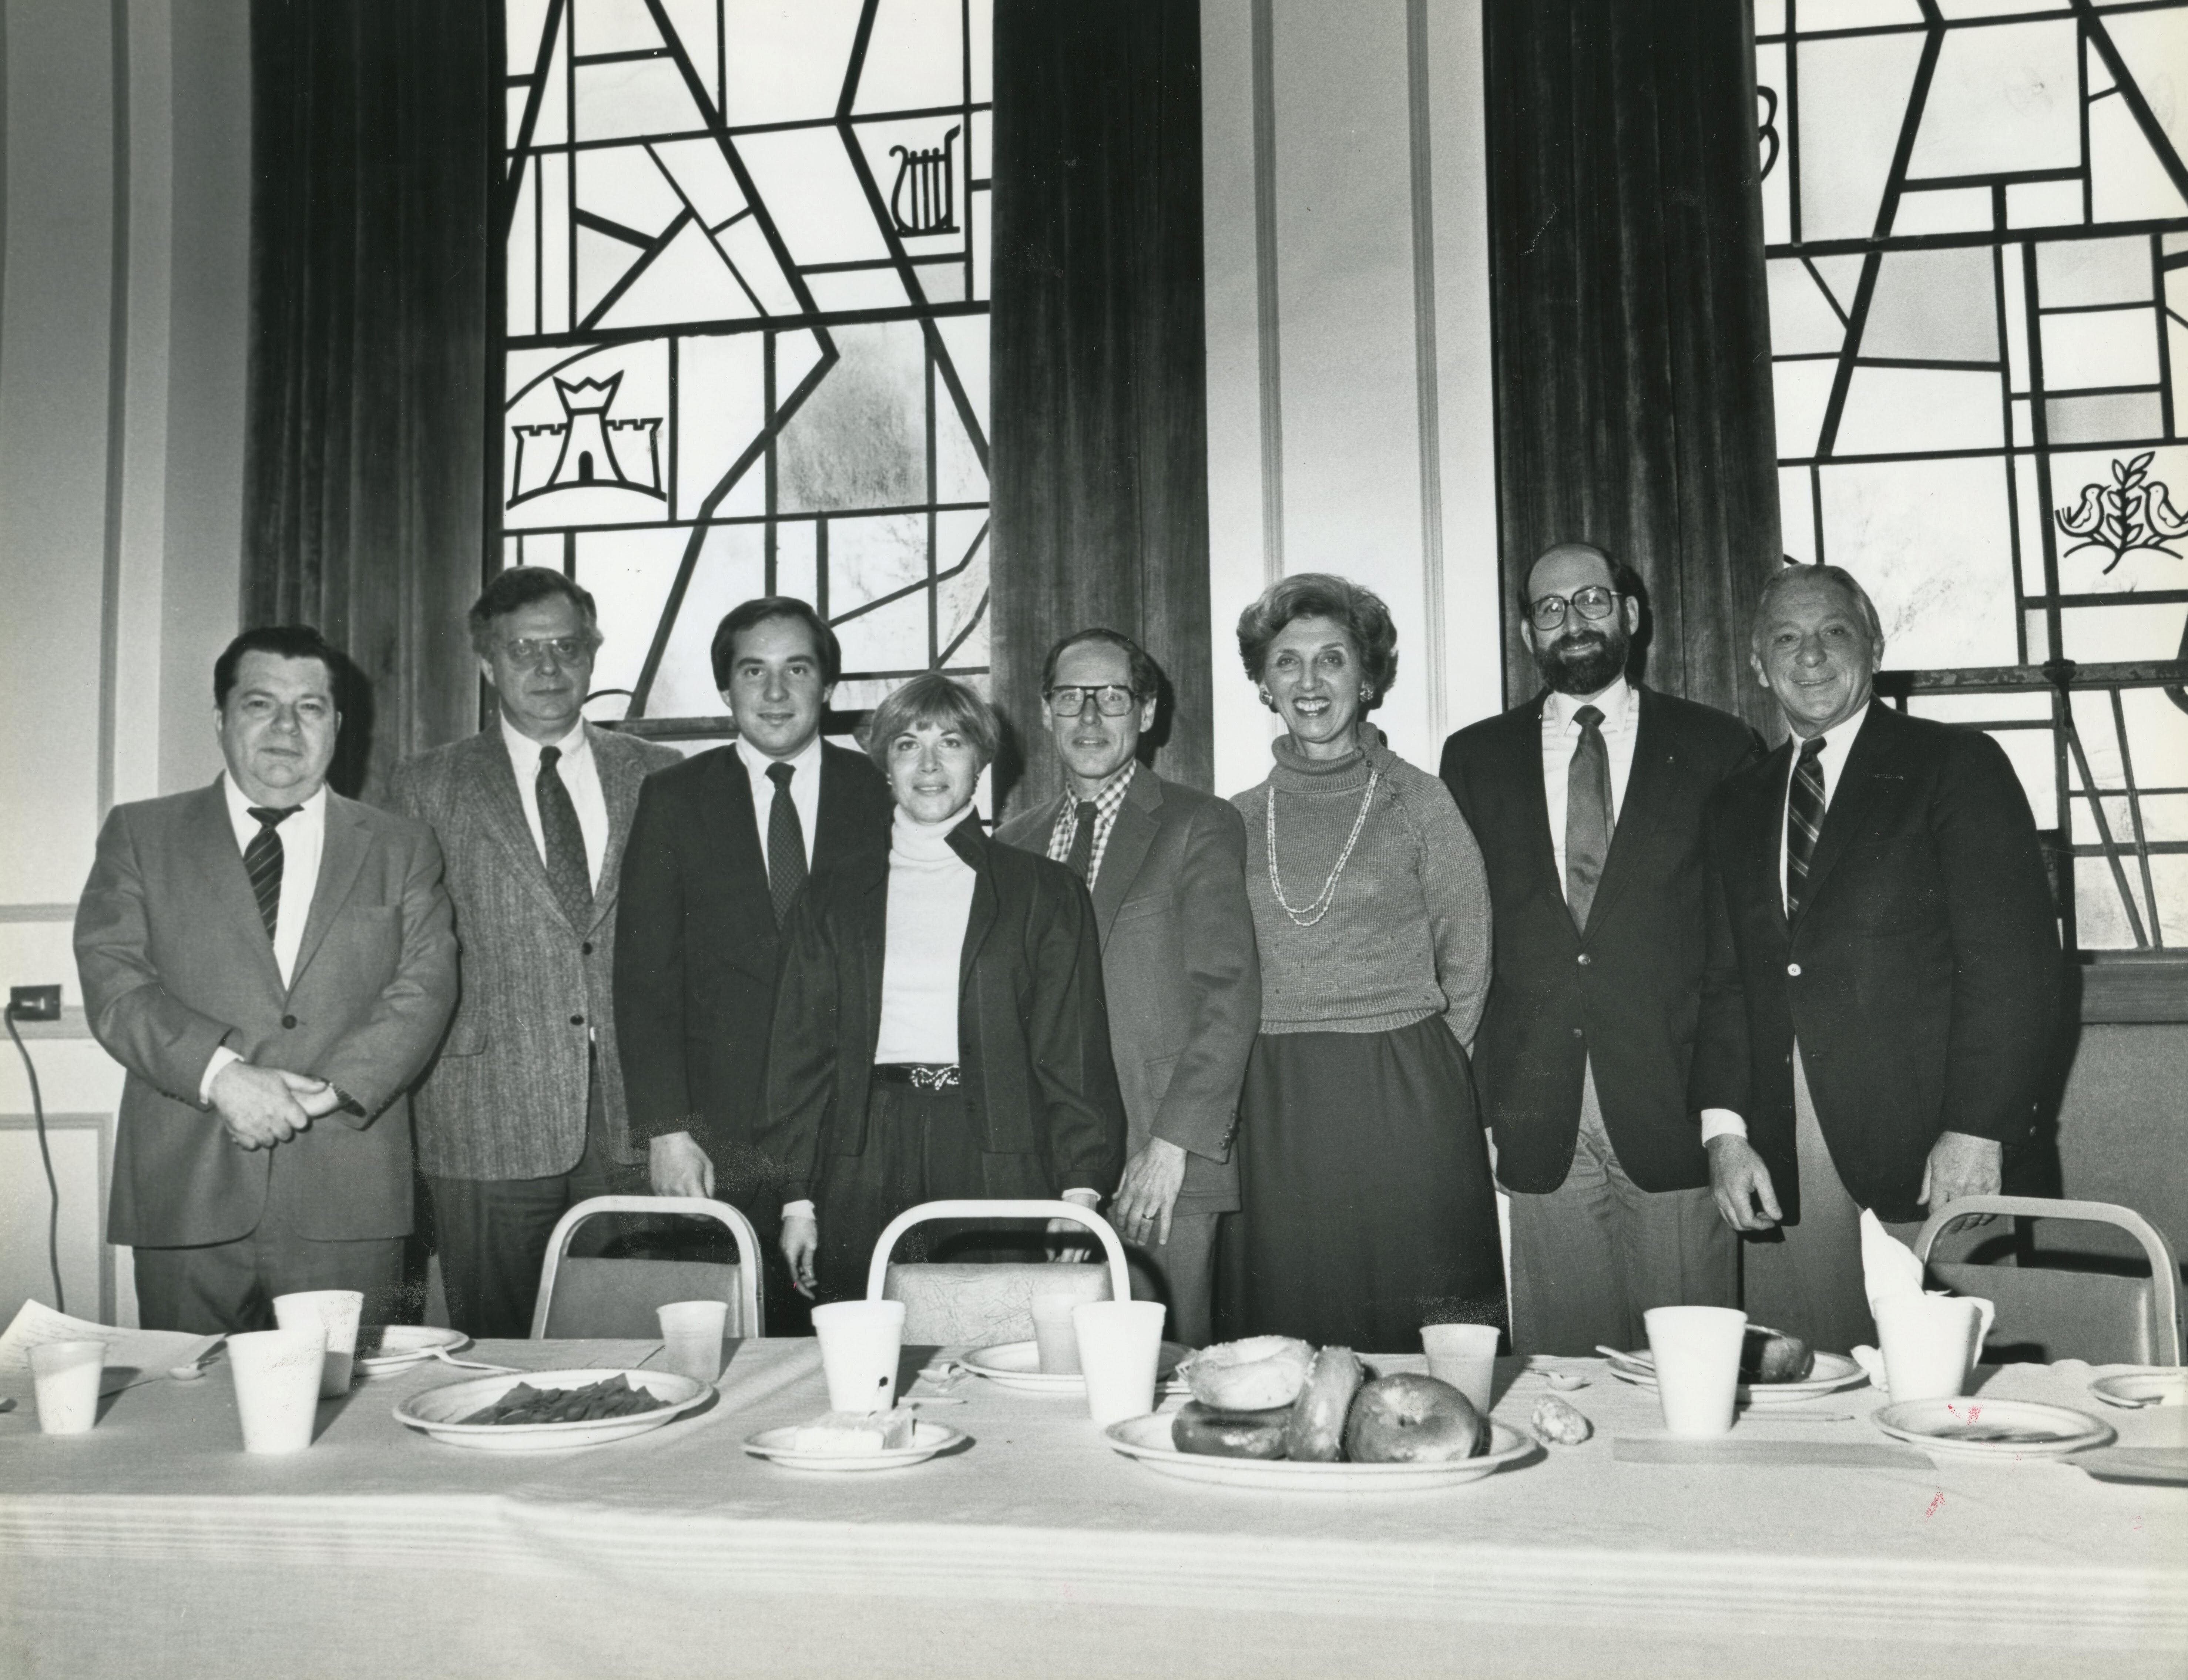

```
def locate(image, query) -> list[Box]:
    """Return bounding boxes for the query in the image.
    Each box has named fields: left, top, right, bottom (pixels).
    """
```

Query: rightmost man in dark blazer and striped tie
left=1696, top=567, right=2061, bottom=1350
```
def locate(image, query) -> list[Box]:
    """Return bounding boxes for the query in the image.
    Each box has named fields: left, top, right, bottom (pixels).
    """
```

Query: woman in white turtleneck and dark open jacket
left=759, top=674, right=1125, bottom=1299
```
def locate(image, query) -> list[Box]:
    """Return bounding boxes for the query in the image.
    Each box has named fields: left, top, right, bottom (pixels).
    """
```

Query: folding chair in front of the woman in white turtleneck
left=866, top=1201, right=1131, bottom=1347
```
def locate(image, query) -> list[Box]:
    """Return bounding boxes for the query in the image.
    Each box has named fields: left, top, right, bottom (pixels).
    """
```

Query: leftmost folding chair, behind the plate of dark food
left=532, top=1197, right=764, bottom=1339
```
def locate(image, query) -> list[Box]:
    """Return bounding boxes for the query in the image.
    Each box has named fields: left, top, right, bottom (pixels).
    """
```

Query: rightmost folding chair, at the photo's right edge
left=1914, top=1197, right=2181, bottom=1365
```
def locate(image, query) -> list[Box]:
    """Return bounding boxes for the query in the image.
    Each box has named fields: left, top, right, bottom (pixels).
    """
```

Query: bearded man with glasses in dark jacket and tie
left=1442, top=542, right=1761, bottom=1354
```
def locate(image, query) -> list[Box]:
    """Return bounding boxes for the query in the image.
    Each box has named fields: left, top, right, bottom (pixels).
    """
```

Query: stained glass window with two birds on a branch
left=1755, top=0, right=2188, bottom=947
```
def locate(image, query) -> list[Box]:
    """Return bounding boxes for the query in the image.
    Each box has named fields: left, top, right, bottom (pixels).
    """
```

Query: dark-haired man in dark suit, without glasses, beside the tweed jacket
left=615, top=595, right=893, bottom=1332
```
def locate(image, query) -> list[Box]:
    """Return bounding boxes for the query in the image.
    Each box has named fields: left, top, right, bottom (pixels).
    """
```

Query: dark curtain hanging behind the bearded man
left=1483, top=0, right=1781, bottom=722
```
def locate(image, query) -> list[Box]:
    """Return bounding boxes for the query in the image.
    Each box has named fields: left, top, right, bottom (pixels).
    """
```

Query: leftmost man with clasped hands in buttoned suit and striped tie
left=77, top=626, right=455, bottom=1332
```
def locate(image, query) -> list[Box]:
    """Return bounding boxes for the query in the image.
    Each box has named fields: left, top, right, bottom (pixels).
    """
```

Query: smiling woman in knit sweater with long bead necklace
left=1223, top=573, right=1505, bottom=1352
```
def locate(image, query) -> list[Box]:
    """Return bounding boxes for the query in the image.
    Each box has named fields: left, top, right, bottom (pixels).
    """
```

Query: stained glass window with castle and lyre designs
left=497, top=0, right=991, bottom=739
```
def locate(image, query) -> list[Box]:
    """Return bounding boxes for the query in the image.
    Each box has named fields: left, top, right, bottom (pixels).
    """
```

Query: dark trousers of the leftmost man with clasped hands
left=134, top=1214, right=403, bottom=1337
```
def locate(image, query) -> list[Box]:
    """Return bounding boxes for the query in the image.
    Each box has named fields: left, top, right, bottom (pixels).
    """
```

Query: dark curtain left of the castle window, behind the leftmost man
left=243, top=0, right=501, bottom=796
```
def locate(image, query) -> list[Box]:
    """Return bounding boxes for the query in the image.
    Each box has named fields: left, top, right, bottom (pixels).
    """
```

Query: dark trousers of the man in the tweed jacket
left=427, top=1063, right=645, bottom=1339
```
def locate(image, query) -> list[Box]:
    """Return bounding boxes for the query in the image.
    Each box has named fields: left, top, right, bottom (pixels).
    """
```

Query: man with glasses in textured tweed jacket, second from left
left=389, top=567, right=681, bottom=1337
